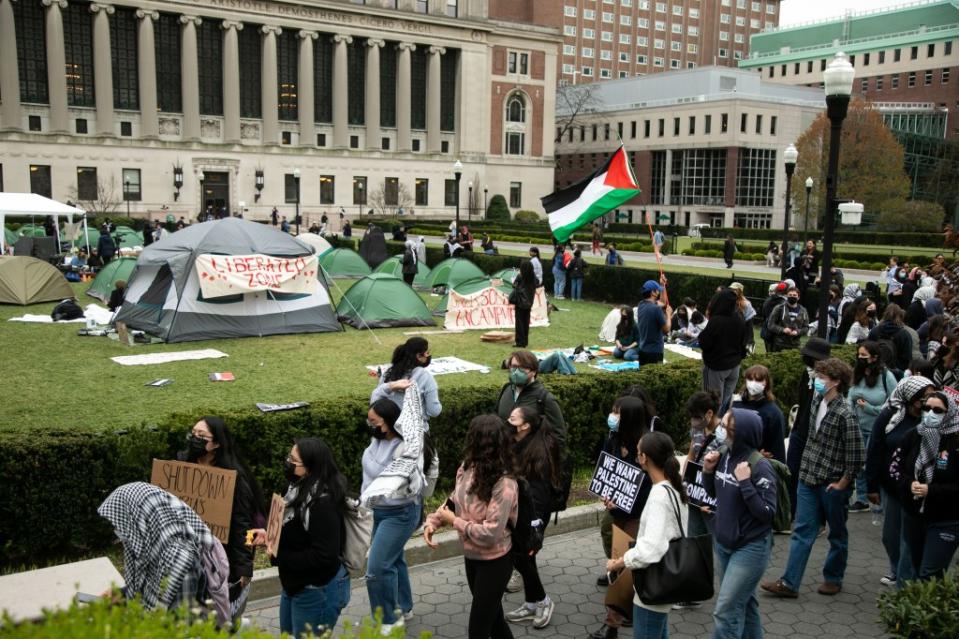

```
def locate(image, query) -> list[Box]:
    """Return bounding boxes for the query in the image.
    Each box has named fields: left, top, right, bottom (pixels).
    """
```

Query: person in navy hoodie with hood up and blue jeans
left=703, top=408, right=776, bottom=639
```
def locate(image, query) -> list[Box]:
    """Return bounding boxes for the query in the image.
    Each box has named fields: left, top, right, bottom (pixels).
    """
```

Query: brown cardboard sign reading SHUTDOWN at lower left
left=150, top=459, right=236, bottom=543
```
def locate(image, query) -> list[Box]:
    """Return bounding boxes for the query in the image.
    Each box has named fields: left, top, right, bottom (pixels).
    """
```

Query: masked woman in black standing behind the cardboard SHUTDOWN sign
left=176, top=416, right=266, bottom=620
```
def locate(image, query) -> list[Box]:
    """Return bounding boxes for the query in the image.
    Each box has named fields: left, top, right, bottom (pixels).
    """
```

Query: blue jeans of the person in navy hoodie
left=713, top=532, right=773, bottom=639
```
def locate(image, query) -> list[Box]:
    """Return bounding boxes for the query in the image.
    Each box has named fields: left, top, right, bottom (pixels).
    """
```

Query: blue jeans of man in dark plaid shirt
left=782, top=482, right=850, bottom=590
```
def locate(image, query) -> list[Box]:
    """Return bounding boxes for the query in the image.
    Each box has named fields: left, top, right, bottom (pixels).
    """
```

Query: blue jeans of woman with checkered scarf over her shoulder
left=366, top=502, right=422, bottom=624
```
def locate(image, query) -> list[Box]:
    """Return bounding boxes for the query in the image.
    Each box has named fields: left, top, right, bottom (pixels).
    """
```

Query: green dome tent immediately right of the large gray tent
left=336, top=273, right=436, bottom=328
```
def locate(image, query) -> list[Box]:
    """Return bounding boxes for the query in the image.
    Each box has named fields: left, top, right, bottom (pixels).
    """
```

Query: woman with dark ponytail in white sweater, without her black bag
left=606, top=432, right=689, bottom=639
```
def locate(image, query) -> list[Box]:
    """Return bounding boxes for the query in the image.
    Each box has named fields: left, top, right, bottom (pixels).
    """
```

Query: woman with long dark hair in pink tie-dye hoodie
left=423, top=415, right=519, bottom=639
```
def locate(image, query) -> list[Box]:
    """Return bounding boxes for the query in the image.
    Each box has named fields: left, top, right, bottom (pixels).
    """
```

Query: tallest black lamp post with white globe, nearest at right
left=817, top=51, right=856, bottom=338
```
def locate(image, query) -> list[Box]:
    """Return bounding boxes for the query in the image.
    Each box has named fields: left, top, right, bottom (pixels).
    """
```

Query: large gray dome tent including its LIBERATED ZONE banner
left=116, top=218, right=341, bottom=342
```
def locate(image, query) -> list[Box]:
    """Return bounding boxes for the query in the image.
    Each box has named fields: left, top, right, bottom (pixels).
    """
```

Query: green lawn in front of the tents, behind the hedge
left=0, top=280, right=688, bottom=428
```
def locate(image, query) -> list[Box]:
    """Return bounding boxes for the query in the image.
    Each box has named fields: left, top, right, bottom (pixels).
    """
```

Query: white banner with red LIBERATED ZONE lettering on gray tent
left=196, top=254, right=317, bottom=298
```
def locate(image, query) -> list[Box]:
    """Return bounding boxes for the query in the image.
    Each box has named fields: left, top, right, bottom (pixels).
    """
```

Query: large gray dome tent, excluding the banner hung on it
left=116, top=218, right=342, bottom=342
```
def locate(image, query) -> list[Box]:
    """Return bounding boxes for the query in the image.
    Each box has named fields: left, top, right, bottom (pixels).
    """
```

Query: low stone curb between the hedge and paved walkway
left=249, top=504, right=605, bottom=607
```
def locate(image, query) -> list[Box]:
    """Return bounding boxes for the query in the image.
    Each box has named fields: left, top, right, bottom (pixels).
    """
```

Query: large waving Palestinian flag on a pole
left=541, top=146, right=640, bottom=242
